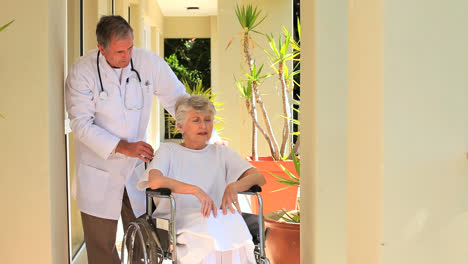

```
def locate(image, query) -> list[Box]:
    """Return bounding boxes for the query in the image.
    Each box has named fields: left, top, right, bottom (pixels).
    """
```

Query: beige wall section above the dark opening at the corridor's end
left=164, top=16, right=211, bottom=38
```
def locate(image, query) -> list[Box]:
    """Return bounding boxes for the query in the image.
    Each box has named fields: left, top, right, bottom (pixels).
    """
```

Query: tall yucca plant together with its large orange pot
left=227, top=5, right=300, bottom=213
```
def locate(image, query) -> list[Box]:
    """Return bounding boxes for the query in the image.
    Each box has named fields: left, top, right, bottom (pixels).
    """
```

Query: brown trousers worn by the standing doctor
left=81, top=189, right=141, bottom=264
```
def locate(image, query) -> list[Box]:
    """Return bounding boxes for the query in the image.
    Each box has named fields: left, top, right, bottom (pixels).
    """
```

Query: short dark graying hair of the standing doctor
left=96, top=16, right=133, bottom=50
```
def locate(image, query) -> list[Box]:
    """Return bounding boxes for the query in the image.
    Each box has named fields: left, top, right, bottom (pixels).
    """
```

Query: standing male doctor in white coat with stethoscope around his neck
left=65, top=16, right=219, bottom=264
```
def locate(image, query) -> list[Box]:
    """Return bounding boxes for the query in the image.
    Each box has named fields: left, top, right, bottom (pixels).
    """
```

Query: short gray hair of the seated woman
left=175, top=95, right=216, bottom=125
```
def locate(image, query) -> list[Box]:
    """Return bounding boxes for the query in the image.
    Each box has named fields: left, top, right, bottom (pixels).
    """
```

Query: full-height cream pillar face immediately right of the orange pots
left=301, top=0, right=348, bottom=264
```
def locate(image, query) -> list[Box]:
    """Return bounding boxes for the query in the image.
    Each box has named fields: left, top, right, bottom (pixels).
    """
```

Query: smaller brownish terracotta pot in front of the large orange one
left=265, top=217, right=301, bottom=264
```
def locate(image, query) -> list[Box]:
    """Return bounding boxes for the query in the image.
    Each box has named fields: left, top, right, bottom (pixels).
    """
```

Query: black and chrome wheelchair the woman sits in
left=121, top=185, right=270, bottom=264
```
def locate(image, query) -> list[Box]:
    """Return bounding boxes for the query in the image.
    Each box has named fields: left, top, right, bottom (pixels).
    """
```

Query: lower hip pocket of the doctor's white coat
left=77, top=164, right=110, bottom=202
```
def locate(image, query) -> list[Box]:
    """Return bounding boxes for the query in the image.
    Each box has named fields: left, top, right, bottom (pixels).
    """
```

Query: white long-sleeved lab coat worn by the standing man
left=65, top=48, right=191, bottom=220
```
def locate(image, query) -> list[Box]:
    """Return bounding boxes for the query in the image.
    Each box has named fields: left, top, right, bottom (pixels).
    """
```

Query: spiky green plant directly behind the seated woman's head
left=166, top=80, right=224, bottom=138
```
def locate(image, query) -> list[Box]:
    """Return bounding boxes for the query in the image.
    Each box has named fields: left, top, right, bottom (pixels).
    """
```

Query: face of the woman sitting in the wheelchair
left=178, top=110, right=213, bottom=148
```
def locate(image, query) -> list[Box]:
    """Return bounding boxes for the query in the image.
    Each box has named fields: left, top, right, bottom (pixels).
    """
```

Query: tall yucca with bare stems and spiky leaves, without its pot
left=227, top=5, right=300, bottom=160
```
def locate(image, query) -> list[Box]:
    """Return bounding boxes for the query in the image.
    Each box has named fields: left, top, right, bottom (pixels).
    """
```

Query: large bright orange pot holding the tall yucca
left=246, top=157, right=298, bottom=214
